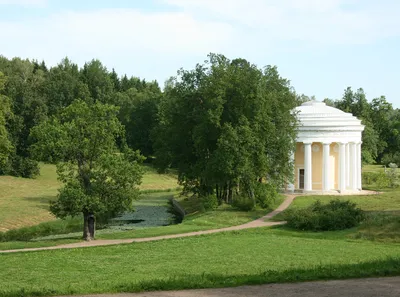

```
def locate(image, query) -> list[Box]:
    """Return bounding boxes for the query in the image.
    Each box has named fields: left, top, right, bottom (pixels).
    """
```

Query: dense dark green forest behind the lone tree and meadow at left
left=0, top=56, right=162, bottom=177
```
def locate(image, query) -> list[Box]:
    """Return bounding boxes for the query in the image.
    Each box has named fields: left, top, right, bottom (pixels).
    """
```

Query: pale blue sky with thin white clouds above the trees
left=0, top=0, right=400, bottom=108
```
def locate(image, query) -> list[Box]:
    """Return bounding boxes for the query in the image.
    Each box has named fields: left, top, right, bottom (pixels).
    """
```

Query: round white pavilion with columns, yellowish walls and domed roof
left=289, top=101, right=364, bottom=193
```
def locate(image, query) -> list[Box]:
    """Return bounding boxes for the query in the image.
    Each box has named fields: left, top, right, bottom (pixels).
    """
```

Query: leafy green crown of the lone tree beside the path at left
left=31, top=100, right=143, bottom=238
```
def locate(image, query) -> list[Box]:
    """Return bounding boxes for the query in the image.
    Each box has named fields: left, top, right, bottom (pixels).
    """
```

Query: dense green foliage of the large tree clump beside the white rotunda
left=153, top=54, right=297, bottom=203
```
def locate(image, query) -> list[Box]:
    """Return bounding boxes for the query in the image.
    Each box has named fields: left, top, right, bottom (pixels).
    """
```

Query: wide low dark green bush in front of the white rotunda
left=284, top=199, right=365, bottom=231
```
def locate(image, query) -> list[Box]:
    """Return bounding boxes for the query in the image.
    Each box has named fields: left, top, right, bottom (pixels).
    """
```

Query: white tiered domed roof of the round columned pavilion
left=295, top=101, right=364, bottom=140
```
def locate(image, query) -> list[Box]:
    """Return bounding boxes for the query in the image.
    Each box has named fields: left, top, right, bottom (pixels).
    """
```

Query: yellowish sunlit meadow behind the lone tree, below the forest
left=0, top=164, right=178, bottom=232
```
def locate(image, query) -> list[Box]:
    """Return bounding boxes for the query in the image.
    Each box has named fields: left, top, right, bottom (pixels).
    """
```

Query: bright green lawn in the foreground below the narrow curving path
left=0, top=228, right=400, bottom=296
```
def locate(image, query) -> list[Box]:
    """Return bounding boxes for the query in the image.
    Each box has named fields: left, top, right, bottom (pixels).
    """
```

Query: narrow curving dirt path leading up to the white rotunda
left=0, top=195, right=297, bottom=253
